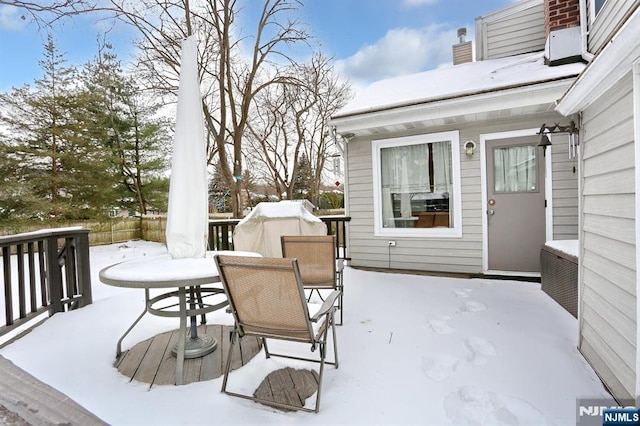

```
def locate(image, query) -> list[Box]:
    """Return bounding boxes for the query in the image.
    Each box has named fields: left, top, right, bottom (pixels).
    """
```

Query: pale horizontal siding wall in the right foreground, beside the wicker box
left=579, top=71, right=637, bottom=399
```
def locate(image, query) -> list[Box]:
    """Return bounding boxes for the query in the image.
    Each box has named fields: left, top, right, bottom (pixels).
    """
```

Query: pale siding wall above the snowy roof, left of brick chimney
left=476, top=0, right=546, bottom=60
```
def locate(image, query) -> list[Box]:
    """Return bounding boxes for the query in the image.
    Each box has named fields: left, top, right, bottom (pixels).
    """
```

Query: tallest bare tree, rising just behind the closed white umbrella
left=111, top=0, right=308, bottom=217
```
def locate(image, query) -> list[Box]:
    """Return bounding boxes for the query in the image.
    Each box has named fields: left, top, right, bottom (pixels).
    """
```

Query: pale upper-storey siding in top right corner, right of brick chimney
left=586, top=0, right=640, bottom=54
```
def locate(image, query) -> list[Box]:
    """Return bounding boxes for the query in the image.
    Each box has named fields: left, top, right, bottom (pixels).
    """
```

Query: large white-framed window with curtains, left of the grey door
left=372, top=132, right=462, bottom=237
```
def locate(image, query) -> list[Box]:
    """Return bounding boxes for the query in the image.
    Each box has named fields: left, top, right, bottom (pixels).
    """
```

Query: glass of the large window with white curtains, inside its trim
left=380, top=141, right=454, bottom=228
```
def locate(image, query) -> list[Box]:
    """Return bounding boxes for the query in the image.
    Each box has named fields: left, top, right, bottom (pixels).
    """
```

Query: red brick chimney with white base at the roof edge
left=544, top=0, right=582, bottom=66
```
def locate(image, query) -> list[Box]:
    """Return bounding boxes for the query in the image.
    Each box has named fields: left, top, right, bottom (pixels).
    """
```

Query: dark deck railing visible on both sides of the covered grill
left=209, top=216, right=351, bottom=260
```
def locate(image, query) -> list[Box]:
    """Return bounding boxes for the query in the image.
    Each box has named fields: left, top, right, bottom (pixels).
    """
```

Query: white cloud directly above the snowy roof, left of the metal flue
left=336, top=23, right=470, bottom=88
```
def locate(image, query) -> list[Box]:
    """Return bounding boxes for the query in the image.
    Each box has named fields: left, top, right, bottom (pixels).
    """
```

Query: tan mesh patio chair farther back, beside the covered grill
left=280, top=235, right=344, bottom=325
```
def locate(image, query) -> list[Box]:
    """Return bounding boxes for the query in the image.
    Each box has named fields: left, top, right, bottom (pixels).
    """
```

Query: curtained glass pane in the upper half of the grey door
left=493, top=145, right=538, bottom=192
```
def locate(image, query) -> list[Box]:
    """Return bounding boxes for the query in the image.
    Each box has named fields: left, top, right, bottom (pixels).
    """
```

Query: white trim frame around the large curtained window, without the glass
left=371, top=130, right=462, bottom=238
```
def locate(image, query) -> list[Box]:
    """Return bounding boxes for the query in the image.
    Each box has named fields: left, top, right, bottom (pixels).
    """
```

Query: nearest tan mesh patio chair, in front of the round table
left=214, top=255, right=340, bottom=413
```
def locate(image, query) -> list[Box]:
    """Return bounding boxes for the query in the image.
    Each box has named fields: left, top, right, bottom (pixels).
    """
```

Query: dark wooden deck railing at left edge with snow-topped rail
left=0, top=228, right=92, bottom=342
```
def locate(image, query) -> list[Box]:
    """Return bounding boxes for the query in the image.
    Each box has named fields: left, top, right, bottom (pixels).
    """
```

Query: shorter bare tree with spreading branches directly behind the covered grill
left=249, top=54, right=350, bottom=204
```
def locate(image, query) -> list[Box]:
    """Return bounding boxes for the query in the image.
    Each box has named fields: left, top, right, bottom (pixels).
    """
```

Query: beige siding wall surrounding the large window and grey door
left=346, top=113, right=577, bottom=273
